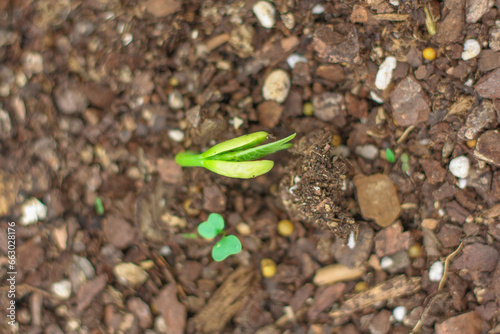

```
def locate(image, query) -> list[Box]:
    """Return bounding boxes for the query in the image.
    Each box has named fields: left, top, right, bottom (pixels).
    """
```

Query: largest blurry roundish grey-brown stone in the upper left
left=54, top=84, right=89, bottom=115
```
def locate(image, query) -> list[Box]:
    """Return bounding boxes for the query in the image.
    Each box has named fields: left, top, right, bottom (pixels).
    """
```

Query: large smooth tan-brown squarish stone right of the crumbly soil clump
left=353, top=174, right=401, bottom=227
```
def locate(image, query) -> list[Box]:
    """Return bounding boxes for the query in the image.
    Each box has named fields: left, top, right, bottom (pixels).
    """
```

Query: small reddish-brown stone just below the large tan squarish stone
left=374, top=222, right=411, bottom=257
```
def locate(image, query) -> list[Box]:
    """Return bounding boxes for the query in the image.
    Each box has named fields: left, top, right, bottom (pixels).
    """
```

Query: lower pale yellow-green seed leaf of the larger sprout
left=203, top=160, right=274, bottom=179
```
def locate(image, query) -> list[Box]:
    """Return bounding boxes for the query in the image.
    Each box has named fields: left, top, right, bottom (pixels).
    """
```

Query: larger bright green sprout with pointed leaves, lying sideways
left=175, top=131, right=296, bottom=179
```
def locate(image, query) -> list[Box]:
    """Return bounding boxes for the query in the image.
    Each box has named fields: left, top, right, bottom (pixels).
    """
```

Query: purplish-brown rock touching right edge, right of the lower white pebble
left=452, top=243, right=498, bottom=272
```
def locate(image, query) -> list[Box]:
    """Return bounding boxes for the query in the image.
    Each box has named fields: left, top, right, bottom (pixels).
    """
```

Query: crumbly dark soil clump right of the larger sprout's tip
left=280, top=131, right=357, bottom=238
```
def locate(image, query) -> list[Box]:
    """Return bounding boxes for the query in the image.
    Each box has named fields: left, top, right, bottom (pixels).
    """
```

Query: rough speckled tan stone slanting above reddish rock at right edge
left=458, top=100, right=497, bottom=140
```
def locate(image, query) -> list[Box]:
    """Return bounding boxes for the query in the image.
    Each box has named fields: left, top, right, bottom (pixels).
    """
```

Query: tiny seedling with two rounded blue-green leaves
left=198, top=213, right=241, bottom=261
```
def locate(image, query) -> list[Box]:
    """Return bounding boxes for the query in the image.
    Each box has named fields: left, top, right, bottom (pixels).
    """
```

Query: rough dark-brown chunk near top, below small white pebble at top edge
left=313, top=25, right=359, bottom=63
